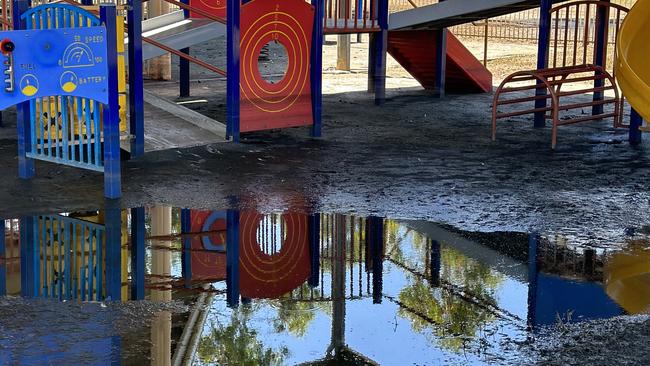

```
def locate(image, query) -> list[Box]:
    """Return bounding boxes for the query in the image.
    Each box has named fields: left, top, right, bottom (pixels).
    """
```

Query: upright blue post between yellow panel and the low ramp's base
left=126, top=0, right=144, bottom=158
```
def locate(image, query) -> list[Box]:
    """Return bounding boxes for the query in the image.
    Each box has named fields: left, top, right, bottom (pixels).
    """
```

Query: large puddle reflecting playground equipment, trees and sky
left=0, top=204, right=650, bottom=365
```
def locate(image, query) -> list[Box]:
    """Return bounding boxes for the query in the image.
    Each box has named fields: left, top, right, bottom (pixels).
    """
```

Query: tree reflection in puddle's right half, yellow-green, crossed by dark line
left=399, top=248, right=502, bottom=351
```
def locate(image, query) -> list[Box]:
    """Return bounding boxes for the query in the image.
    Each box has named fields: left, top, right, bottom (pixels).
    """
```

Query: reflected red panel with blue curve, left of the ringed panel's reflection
left=190, top=210, right=226, bottom=280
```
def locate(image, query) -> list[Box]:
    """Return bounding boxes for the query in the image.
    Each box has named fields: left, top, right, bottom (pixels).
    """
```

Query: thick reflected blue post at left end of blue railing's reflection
left=20, top=216, right=41, bottom=297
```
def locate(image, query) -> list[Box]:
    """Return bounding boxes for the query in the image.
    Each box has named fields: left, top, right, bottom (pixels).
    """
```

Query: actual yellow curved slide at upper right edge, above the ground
left=616, top=0, right=650, bottom=122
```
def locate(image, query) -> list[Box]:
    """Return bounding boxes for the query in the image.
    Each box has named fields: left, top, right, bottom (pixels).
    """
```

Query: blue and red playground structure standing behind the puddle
left=0, top=0, right=647, bottom=198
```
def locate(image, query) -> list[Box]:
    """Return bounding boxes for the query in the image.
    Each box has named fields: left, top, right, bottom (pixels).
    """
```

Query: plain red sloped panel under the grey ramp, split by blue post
left=388, top=30, right=492, bottom=93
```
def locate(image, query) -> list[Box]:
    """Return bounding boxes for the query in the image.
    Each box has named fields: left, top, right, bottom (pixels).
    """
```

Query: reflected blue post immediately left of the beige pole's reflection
left=131, top=207, right=146, bottom=300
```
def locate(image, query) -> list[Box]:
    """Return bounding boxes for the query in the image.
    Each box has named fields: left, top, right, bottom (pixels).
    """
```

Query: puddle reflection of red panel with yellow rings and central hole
left=239, top=211, right=310, bottom=298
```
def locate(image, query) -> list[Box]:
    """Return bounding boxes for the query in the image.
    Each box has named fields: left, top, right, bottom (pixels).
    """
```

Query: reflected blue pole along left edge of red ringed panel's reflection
left=226, top=210, right=239, bottom=307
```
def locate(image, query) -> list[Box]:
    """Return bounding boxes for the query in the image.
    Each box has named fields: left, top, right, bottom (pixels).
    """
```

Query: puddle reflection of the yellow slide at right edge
left=604, top=247, right=650, bottom=314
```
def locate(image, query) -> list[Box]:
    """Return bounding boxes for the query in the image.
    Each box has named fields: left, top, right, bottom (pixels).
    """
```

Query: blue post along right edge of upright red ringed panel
left=311, top=0, right=325, bottom=137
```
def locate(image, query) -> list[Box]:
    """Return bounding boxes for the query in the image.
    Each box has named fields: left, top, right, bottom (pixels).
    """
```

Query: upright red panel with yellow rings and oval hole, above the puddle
left=240, top=0, right=314, bottom=132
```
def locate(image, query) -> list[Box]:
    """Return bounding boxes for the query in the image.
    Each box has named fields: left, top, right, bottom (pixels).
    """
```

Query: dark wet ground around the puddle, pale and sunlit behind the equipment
left=0, top=33, right=650, bottom=364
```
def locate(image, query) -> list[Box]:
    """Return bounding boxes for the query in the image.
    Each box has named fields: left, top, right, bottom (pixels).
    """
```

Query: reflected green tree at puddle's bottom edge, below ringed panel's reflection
left=198, top=306, right=289, bottom=366
